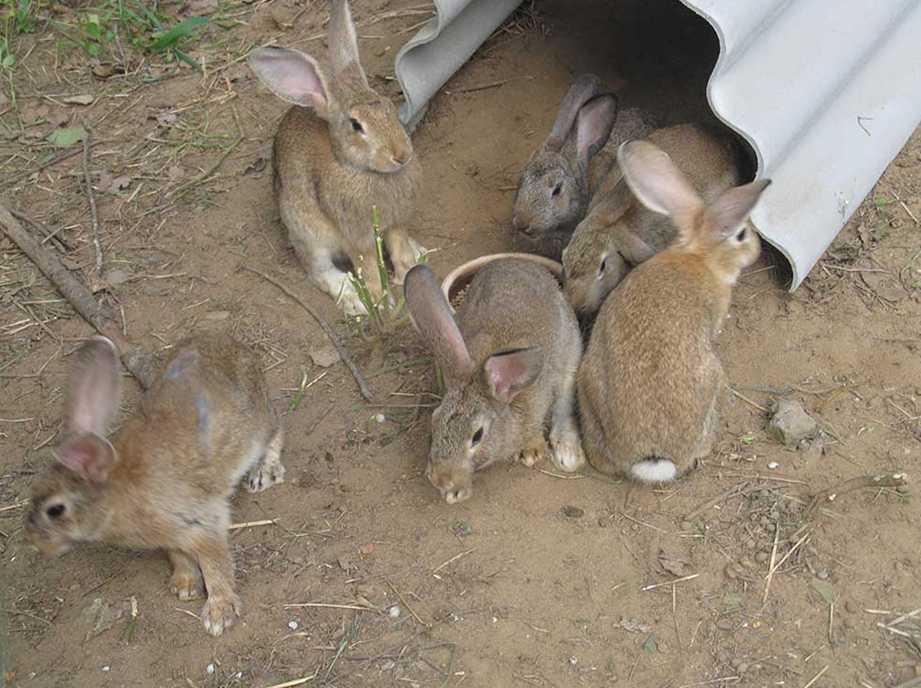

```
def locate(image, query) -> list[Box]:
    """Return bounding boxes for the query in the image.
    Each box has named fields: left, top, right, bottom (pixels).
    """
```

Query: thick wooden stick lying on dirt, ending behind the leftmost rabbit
left=0, top=204, right=154, bottom=389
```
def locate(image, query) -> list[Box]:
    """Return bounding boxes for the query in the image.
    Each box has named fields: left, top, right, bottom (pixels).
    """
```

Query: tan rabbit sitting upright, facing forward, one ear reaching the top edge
left=249, top=0, right=424, bottom=315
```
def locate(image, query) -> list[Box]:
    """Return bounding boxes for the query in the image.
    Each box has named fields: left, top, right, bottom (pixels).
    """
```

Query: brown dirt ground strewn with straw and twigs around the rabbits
left=0, top=0, right=921, bottom=688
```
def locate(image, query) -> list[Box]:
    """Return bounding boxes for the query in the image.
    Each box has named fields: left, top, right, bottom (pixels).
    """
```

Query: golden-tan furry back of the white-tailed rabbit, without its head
left=578, top=260, right=724, bottom=479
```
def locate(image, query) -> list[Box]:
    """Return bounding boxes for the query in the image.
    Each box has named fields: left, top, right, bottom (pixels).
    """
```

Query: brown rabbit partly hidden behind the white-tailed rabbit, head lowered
left=562, top=124, right=742, bottom=316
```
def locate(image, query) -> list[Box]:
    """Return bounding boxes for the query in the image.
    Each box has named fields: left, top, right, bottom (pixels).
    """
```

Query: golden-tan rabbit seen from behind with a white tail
left=578, top=141, right=770, bottom=482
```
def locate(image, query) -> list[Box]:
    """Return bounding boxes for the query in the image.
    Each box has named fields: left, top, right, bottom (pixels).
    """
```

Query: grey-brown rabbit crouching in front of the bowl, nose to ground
left=404, top=258, right=585, bottom=504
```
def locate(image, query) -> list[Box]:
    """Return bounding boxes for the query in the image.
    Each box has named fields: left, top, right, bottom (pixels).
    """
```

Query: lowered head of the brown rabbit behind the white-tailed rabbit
left=562, top=179, right=656, bottom=314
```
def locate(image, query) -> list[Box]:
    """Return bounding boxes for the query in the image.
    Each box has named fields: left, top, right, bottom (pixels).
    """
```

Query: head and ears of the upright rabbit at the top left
left=248, top=0, right=413, bottom=174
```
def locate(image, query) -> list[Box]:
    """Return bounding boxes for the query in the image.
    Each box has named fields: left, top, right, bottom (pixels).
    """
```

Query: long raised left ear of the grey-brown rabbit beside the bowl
left=403, top=265, right=473, bottom=380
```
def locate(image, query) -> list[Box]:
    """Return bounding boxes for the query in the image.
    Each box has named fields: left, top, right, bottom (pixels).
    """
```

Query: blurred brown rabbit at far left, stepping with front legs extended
left=26, top=335, right=285, bottom=636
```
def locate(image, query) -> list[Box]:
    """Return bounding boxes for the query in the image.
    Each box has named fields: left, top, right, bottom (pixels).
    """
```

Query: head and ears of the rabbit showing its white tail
left=617, top=141, right=771, bottom=286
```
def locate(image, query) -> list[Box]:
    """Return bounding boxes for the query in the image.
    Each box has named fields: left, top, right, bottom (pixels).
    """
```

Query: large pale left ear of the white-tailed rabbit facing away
left=617, top=141, right=704, bottom=226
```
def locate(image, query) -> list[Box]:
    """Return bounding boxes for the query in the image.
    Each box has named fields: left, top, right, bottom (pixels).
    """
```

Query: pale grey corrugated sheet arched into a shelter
left=396, top=0, right=921, bottom=289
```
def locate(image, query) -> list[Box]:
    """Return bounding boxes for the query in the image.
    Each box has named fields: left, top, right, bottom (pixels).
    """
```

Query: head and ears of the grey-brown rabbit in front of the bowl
left=404, top=265, right=543, bottom=504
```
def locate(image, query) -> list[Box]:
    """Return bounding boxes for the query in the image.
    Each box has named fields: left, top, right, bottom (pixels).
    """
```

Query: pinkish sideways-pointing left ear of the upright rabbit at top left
left=247, top=46, right=330, bottom=117
